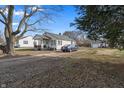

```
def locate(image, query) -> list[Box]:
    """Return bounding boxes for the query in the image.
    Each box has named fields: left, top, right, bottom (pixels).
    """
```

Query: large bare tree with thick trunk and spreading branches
left=0, top=5, right=61, bottom=55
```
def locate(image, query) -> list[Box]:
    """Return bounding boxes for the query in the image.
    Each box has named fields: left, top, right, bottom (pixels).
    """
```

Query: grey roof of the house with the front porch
left=34, top=32, right=73, bottom=41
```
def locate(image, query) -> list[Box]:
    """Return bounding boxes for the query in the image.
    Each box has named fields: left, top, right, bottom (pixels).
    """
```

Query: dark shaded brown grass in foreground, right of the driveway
left=33, top=58, right=124, bottom=88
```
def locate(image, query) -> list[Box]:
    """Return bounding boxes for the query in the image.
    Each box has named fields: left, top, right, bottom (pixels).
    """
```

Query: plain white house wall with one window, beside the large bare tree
left=15, top=36, right=34, bottom=48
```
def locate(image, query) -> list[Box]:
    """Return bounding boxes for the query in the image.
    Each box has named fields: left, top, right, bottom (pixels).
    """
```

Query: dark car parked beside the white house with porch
left=61, top=44, right=78, bottom=52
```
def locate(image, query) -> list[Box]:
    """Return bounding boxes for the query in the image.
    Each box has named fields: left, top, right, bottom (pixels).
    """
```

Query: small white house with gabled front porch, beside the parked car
left=34, top=32, right=76, bottom=50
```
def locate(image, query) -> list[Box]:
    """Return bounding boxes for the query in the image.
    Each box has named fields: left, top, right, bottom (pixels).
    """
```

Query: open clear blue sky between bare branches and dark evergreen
left=40, top=6, right=77, bottom=33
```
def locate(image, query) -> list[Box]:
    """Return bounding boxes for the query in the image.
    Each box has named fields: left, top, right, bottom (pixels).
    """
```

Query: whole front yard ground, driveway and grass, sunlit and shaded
left=0, top=48, right=124, bottom=87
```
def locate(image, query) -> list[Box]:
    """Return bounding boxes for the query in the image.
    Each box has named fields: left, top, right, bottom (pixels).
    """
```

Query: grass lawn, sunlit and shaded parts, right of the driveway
left=24, top=48, right=124, bottom=88
